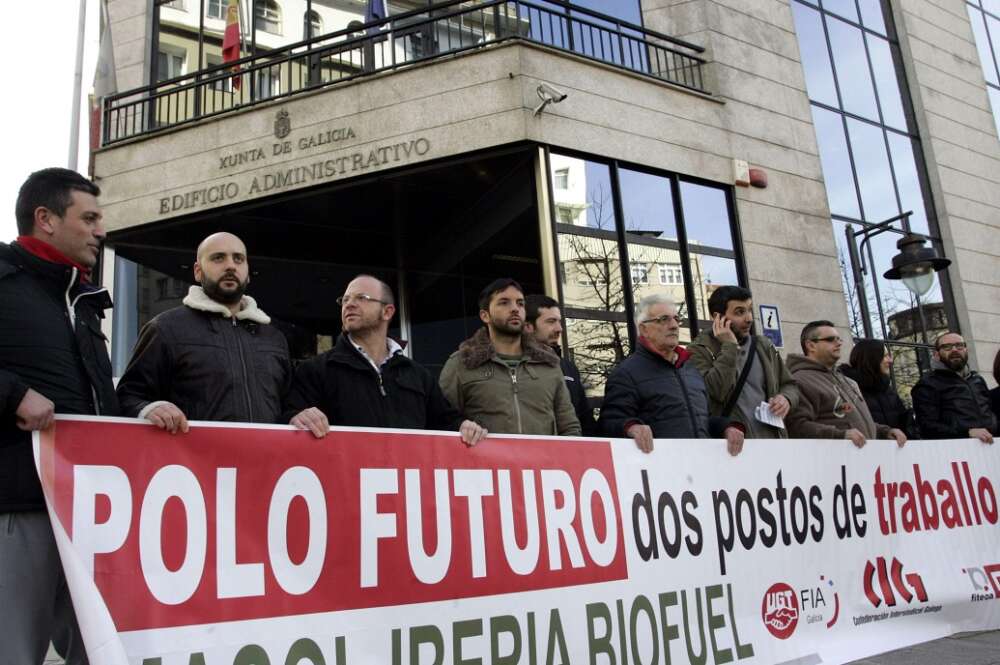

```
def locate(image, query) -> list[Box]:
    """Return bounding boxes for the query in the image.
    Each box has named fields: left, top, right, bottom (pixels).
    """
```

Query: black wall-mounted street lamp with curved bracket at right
left=845, top=210, right=951, bottom=345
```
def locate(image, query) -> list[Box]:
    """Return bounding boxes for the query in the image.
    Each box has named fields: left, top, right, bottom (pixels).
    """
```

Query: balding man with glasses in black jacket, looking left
left=286, top=275, right=486, bottom=446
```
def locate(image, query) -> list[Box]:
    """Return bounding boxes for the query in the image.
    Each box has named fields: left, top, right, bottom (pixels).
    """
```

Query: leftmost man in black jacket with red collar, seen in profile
left=0, top=168, right=118, bottom=663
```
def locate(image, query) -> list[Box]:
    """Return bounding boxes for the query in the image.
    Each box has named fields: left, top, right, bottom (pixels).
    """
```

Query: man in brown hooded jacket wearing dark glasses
left=785, top=320, right=906, bottom=448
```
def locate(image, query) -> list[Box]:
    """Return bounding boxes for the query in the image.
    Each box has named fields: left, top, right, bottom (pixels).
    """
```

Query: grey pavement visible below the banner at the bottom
left=44, top=630, right=1000, bottom=665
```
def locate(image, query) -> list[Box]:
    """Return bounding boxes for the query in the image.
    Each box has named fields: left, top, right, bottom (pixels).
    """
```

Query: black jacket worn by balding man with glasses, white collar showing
left=285, top=334, right=462, bottom=431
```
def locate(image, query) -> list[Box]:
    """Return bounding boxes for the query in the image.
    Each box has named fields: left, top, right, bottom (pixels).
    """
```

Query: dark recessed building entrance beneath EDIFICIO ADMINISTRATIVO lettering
left=109, top=147, right=543, bottom=375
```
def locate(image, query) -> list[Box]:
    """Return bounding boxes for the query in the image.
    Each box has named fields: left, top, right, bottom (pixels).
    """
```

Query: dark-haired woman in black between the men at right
left=840, top=339, right=920, bottom=439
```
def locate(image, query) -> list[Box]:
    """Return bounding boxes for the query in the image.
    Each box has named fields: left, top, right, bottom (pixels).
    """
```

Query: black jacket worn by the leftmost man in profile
left=0, top=242, right=118, bottom=513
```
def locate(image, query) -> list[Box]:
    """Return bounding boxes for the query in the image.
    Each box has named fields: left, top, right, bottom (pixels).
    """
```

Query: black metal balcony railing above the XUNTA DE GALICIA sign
left=101, top=0, right=705, bottom=146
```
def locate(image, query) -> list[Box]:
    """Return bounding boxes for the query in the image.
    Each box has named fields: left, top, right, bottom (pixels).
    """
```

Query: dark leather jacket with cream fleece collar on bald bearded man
left=118, top=286, right=292, bottom=423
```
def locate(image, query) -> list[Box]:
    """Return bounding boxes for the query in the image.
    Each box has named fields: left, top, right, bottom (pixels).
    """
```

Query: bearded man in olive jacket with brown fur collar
left=440, top=278, right=581, bottom=436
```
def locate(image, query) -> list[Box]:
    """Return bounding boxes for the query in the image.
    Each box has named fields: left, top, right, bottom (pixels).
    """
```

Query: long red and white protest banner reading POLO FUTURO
left=35, top=417, right=1000, bottom=665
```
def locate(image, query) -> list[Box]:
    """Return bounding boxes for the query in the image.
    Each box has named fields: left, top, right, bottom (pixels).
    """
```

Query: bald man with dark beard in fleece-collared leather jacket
left=118, top=233, right=294, bottom=436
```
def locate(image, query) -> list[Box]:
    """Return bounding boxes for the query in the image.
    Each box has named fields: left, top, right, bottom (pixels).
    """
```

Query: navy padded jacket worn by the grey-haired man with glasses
left=600, top=340, right=725, bottom=439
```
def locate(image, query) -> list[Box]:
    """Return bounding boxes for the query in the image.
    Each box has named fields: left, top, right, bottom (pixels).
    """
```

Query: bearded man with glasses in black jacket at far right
left=911, top=332, right=1000, bottom=443
